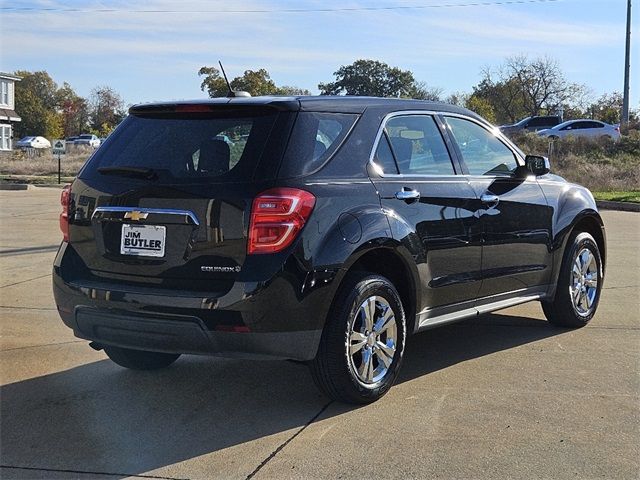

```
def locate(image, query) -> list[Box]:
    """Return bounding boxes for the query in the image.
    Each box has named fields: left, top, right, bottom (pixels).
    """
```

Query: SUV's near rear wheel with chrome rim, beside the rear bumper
left=310, top=272, right=406, bottom=404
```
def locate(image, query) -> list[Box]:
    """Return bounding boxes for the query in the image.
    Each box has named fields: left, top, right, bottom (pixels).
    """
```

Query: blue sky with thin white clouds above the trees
left=0, top=0, right=640, bottom=109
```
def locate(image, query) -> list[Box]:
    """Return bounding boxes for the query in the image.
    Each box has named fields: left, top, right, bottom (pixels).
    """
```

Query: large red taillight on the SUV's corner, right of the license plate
left=247, top=188, right=316, bottom=254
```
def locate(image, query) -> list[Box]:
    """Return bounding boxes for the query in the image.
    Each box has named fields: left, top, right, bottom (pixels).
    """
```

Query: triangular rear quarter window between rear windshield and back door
left=279, top=112, right=358, bottom=177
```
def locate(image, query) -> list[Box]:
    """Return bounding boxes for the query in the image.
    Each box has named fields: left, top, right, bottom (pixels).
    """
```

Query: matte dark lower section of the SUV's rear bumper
left=71, top=307, right=322, bottom=360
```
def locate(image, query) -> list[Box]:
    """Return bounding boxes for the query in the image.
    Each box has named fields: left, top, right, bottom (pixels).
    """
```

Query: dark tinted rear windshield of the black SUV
left=81, top=109, right=278, bottom=183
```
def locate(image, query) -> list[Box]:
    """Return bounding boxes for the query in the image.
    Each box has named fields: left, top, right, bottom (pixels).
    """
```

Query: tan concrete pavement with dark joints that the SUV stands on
left=0, top=188, right=640, bottom=479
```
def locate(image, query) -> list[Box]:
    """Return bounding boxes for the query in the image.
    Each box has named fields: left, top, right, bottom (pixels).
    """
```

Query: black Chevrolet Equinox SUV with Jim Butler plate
left=53, top=97, right=605, bottom=403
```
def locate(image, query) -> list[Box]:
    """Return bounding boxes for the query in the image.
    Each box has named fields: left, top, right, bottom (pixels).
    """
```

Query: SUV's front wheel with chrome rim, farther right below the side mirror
left=542, top=232, right=603, bottom=328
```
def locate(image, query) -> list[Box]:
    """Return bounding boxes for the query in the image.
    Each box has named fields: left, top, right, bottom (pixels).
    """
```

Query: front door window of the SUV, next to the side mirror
left=447, top=117, right=518, bottom=175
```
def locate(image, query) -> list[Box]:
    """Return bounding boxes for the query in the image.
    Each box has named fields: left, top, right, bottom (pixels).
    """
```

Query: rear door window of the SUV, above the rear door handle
left=385, top=115, right=455, bottom=175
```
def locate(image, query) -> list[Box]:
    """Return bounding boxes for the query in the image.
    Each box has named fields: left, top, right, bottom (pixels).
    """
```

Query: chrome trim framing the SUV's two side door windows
left=368, top=110, right=525, bottom=179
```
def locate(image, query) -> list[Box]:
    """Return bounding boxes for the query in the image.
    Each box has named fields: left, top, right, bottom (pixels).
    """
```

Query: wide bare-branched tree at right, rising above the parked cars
left=473, top=55, right=586, bottom=122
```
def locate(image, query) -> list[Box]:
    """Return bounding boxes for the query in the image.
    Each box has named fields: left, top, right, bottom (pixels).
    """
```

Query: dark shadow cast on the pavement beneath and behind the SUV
left=0, top=314, right=564, bottom=477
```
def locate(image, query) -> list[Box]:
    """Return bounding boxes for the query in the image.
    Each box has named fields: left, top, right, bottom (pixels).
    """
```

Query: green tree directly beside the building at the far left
left=14, top=70, right=63, bottom=138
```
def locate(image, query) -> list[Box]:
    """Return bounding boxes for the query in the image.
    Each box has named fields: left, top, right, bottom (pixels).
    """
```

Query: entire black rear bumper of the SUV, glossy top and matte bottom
left=53, top=243, right=336, bottom=361
